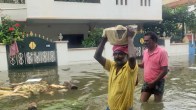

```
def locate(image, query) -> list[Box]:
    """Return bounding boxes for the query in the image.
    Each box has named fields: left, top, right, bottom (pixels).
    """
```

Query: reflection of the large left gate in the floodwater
left=8, top=67, right=59, bottom=84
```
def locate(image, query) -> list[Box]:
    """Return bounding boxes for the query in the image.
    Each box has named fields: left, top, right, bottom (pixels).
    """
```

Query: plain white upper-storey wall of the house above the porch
left=26, top=0, right=162, bottom=20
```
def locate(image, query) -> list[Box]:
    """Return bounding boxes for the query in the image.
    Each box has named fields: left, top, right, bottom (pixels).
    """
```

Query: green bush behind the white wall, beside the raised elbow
left=82, top=28, right=103, bottom=47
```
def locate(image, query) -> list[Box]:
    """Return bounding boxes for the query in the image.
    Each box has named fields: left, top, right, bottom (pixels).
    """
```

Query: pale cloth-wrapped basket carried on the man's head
left=102, top=25, right=135, bottom=45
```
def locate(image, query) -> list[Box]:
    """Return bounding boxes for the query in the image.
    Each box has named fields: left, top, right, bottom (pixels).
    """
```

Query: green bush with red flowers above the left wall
left=0, top=17, right=23, bottom=45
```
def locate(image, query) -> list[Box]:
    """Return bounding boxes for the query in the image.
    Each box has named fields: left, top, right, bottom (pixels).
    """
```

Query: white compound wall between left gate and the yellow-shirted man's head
left=55, top=41, right=110, bottom=66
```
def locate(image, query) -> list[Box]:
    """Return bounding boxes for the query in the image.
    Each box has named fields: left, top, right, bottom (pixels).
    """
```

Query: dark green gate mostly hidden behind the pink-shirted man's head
left=134, top=33, right=165, bottom=58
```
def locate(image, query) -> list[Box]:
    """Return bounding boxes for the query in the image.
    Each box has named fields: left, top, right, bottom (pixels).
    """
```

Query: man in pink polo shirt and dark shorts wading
left=139, top=32, right=168, bottom=102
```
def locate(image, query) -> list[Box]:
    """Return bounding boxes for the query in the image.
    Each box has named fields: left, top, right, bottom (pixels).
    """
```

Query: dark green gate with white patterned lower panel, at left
left=6, top=33, right=57, bottom=69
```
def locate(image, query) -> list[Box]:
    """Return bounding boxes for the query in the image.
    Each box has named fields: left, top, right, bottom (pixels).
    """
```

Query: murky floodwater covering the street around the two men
left=0, top=56, right=196, bottom=110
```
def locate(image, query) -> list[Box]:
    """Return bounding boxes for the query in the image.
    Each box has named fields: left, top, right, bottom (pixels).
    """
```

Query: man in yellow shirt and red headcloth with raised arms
left=94, top=28, right=138, bottom=110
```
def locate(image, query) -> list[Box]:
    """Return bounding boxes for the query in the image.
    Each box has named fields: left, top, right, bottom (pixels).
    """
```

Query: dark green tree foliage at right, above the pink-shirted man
left=144, top=6, right=196, bottom=38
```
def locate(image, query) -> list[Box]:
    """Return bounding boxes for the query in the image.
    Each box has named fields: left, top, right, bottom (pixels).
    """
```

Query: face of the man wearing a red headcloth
left=113, top=51, right=127, bottom=66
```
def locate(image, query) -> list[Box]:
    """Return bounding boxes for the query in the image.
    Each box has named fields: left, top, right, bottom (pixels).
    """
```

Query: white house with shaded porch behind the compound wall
left=0, top=0, right=162, bottom=45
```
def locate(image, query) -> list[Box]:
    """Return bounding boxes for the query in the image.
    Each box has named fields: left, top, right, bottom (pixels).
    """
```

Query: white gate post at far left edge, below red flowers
left=0, top=43, right=8, bottom=71
